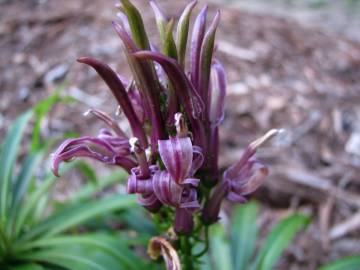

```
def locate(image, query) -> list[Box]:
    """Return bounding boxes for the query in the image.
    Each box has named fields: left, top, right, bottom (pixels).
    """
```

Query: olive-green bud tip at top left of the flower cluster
left=120, top=0, right=150, bottom=50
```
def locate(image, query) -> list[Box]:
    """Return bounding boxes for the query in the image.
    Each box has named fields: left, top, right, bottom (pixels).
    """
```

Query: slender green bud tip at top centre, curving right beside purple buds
left=176, top=0, right=197, bottom=68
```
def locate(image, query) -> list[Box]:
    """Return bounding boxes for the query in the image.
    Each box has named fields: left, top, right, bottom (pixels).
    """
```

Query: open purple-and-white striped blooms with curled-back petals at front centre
left=127, top=119, right=203, bottom=233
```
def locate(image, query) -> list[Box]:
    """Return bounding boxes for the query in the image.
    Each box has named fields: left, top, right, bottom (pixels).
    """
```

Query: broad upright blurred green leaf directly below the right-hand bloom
left=230, top=202, right=259, bottom=270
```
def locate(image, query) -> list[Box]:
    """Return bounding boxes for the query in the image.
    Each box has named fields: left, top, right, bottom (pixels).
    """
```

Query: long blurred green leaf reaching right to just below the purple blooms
left=20, top=195, right=136, bottom=243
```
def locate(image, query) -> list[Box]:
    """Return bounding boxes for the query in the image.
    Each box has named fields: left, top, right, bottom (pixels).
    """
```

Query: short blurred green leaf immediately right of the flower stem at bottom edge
left=209, top=224, right=233, bottom=270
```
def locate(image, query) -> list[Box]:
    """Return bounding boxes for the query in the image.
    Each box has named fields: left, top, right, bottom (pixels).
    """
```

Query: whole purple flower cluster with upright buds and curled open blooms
left=52, top=0, right=277, bottom=235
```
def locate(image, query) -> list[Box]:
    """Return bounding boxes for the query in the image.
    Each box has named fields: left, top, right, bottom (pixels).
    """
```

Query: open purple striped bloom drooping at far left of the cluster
left=51, top=131, right=136, bottom=176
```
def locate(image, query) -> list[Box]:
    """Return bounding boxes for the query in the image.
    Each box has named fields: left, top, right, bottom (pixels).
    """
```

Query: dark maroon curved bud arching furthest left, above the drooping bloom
left=78, top=57, right=148, bottom=148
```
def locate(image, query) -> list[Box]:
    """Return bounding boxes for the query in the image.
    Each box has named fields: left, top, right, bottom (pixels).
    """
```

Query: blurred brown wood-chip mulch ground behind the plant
left=0, top=0, right=360, bottom=269
